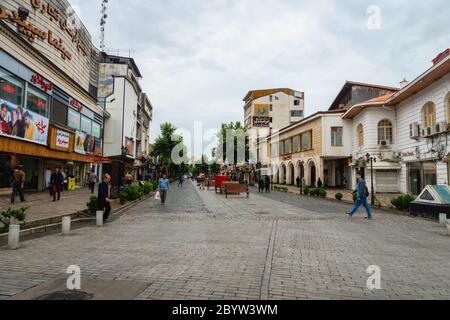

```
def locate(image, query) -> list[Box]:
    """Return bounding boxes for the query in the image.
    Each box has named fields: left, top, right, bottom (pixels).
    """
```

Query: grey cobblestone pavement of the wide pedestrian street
left=0, top=183, right=450, bottom=299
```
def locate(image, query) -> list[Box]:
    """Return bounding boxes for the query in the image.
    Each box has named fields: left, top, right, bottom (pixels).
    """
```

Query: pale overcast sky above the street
left=69, top=0, right=450, bottom=148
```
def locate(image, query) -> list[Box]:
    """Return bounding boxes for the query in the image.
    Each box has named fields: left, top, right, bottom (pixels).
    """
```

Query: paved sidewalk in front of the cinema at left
left=0, top=188, right=120, bottom=222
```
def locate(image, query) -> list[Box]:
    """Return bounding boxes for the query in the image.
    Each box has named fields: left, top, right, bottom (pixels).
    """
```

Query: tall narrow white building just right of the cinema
left=98, top=53, right=153, bottom=196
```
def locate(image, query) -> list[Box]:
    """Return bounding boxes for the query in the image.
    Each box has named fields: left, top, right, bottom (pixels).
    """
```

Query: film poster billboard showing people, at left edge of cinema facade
left=0, top=99, right=49, bottom=145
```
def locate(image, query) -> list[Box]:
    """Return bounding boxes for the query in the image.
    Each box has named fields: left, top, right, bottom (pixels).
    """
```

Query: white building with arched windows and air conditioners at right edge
left=386, top=50, right=450, bottom=194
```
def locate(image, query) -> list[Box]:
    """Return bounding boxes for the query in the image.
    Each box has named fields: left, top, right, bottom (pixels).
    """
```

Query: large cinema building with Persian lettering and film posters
left=0, top=0, right=108, bottom=190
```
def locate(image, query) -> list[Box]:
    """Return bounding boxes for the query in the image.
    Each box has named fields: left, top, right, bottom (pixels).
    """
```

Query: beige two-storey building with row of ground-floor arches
left=267, top=110, right=352, bottom=187
